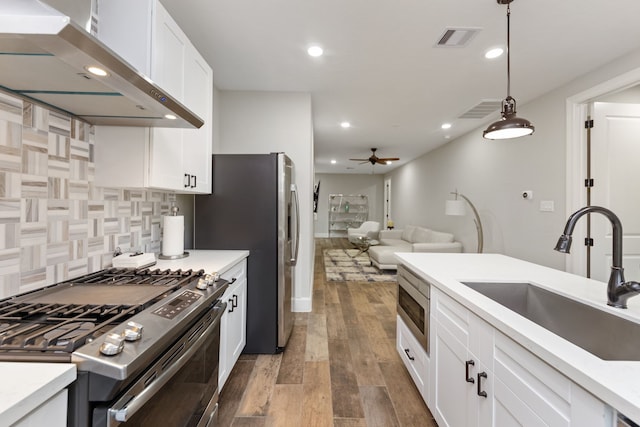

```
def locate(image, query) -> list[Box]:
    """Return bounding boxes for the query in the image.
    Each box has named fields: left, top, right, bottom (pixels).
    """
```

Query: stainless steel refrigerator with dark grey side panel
left=194, top=153, right=300, bottom=354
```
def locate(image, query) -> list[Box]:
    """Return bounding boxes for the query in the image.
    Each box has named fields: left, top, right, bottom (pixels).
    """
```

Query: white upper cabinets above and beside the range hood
left=95, top=0, right=213, bottom=193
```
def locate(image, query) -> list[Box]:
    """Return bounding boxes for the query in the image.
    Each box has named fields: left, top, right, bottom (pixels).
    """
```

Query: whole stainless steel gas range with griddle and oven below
left=0, top=268, right=228, bottom=427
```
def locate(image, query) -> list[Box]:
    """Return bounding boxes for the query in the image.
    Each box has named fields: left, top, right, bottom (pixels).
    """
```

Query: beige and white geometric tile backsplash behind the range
left=0, top=92, right=176, bottom=298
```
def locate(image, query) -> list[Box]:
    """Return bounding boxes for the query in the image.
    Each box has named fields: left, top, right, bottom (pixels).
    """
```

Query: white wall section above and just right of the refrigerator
left=213, top=90, right=314, bottom=311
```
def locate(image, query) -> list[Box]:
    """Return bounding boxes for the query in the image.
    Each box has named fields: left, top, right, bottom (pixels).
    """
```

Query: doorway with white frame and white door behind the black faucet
left=566, top=69, right=640, bottom=281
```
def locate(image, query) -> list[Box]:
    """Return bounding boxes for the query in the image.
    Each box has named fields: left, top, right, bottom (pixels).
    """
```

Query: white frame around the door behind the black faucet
left=565, top=68, right=640, bottom=275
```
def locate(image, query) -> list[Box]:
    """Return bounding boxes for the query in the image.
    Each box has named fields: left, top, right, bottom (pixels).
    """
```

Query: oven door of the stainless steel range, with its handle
left=93, top=302, right=226, bottom=427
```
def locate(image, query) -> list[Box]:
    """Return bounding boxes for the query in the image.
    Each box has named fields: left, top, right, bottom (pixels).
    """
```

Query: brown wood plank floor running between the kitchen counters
left=219, top=239, right=437, bottom=427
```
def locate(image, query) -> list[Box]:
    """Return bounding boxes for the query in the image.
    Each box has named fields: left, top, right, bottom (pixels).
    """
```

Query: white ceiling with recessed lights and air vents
left=161, top=0, right=640, bottom=173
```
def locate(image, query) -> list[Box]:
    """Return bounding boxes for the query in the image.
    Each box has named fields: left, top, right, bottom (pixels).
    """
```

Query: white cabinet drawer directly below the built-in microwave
left=396, top=316, right=429, bottom=401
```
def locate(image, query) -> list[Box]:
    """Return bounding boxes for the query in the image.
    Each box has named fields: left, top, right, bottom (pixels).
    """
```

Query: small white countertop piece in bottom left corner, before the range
left=0, top=362, right=76, bottom=425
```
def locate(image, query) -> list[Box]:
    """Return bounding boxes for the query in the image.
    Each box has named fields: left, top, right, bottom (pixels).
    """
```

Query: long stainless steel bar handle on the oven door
left=107, top=303, right=226, bottom=426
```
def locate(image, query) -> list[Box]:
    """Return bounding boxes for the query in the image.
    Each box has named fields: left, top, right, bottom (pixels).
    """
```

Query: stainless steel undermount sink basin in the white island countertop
left=462, top=282, right=640, bottom=360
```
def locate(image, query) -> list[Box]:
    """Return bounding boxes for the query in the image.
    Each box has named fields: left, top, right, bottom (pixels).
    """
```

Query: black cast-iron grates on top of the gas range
left=0, top=268, right=204, bottom=360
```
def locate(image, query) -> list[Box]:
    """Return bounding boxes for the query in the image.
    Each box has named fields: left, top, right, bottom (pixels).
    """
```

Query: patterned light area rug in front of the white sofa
left=323, top=249, right=396, bottom=282
